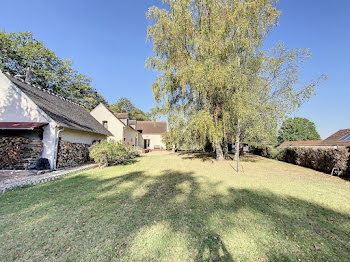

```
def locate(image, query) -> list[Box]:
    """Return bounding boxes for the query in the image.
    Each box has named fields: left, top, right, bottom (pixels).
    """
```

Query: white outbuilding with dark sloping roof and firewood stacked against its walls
left=0, top=71, right=111, bottom=169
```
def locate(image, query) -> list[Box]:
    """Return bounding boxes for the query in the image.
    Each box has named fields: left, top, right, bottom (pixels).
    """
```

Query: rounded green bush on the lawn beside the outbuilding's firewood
left=90, top=140, right=140, bottom=166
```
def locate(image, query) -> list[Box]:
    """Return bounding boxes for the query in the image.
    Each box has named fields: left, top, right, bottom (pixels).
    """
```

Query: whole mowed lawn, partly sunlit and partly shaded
left=0, top=153, right=350, bottom=261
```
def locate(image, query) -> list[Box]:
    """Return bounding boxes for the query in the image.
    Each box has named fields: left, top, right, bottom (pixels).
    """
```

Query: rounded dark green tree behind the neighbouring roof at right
left=278, top=117, right=321, bottom=144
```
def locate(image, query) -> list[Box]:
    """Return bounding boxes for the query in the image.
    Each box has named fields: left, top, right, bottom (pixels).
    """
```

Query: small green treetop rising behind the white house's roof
left=109, top=97, right=151, bottom=121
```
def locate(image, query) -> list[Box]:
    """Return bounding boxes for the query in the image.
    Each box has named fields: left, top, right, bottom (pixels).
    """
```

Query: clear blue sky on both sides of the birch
left=0, top=0, right=350, bottom=138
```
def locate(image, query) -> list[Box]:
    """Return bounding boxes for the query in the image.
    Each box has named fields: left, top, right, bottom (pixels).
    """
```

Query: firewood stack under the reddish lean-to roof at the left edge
left=0, top=137, right=43, bottom=170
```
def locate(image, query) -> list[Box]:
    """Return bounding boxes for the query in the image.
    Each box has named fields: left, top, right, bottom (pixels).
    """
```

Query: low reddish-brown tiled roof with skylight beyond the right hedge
left=279, top=128, right=350, bottom=147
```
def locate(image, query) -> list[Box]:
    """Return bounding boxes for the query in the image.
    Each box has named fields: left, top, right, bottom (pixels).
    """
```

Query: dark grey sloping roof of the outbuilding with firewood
left=5, top=74, right=112, bottom=136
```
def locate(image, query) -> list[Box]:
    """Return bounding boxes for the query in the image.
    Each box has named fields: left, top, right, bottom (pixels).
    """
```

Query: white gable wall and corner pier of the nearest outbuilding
left=0, top=72, right=56, bottom=167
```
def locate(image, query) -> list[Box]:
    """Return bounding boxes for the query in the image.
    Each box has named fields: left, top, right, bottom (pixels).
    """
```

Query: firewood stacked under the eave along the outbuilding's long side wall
left=57, top=140, right=91, bottom=168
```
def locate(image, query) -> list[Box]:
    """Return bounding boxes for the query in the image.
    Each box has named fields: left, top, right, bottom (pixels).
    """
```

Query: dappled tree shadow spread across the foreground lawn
left=0, top=167, right=350, bottom=261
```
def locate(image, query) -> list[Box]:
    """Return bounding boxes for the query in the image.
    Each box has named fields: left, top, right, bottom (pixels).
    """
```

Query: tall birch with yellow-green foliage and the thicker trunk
left=147, top=0, right=279, bottom=160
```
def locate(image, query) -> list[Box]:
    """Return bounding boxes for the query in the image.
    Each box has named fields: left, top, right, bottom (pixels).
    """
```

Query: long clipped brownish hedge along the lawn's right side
left=253, top=146, right=350, bottom=176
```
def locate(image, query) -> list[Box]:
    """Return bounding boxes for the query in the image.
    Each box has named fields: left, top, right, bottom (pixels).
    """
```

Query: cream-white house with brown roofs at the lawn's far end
left=90, top=104, right=167, bottom=150
